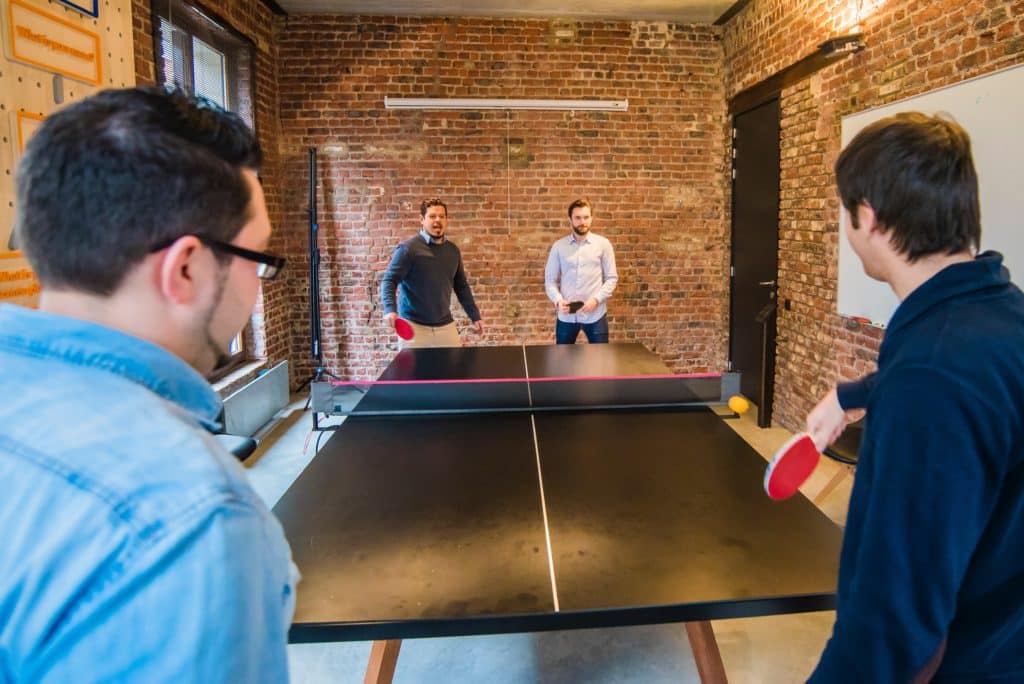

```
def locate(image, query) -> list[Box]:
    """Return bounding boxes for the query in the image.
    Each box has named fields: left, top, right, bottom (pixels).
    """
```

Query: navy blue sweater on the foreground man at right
left=811, top=252, right=1024, bottom=683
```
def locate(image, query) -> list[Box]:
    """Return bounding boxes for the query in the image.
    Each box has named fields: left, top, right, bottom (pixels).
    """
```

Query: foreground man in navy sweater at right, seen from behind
left=807, top=114, right=1024, bottom=682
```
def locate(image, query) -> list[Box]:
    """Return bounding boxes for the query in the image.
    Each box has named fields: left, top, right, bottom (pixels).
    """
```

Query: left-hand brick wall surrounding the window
left=132, top=0, right=292, bottom=377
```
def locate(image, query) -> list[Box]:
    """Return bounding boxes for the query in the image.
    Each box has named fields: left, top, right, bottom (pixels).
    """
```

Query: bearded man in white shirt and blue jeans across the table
left=544, top=200, right=618, bottom=344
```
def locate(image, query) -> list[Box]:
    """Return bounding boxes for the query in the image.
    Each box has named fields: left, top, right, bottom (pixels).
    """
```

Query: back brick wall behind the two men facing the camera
left=279, top=16, right=728, bottom=377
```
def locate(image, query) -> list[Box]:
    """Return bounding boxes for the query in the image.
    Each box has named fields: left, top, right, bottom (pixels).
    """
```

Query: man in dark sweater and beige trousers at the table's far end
left=381, top=199, right=483, bottom=347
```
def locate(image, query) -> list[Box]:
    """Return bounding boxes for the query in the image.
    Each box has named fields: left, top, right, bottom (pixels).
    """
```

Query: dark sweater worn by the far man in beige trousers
left=381, top=233, right=480, bottom=326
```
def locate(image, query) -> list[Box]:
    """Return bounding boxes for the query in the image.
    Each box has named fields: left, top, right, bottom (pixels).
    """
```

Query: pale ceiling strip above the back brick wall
left=276, top=0, right=736, bottom=24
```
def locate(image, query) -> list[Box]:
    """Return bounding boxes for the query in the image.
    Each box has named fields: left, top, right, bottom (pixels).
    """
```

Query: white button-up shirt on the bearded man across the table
left=544, top=232, right=618, bottom=324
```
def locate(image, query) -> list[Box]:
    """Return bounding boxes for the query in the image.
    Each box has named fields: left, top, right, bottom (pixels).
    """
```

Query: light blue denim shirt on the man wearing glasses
left=0, top=305, right=297, bottom=683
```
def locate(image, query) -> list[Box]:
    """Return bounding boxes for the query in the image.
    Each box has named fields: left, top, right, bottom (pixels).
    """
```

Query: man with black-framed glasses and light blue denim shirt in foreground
left=0, top=88, right=297, bottom=683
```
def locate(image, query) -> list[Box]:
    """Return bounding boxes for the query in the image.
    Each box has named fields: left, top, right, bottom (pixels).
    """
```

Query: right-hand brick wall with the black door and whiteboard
left=723, top=0, right=1024, bottom=429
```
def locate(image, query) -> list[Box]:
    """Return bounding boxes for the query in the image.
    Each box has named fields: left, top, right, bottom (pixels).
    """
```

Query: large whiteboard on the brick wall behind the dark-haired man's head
left=838, top=65, right=1024, bottom=327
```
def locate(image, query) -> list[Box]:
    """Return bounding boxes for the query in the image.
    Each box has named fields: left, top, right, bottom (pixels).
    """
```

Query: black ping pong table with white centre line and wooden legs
left=274, top=344, right=842, bottom=682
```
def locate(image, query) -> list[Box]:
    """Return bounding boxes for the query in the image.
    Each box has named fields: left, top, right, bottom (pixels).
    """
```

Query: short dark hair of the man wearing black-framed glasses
left=14, top=87, right=260, bottom=295
